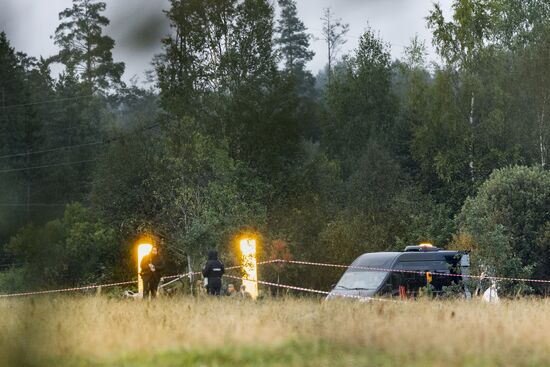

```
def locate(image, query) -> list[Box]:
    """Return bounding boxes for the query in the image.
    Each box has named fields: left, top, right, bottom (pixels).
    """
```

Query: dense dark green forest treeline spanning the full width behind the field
left=0, top=0, right=550, bottom=291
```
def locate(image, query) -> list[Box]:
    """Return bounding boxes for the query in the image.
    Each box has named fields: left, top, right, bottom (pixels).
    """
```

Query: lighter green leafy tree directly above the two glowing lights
left=152, top=121, right=265, bottom=254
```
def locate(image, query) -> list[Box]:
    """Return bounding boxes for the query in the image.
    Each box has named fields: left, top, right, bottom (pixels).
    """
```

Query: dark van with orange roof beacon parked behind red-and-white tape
left=327, top=244, right=470, bottom=299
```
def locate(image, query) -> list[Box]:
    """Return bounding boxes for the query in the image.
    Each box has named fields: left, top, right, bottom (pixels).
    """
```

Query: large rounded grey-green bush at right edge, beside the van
left=458, top=166, right=550, bottom=294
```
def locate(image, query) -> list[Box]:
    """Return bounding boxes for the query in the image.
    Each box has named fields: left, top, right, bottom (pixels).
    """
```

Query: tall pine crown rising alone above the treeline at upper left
left=53, top=0, right=124, bottom=92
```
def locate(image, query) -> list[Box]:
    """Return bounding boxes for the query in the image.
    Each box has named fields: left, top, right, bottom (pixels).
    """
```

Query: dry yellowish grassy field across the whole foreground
left=0, top=296, right=550, bottom=367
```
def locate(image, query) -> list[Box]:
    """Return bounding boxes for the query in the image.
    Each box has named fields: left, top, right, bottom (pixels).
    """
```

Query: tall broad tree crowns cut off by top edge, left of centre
left=155, top=0, right=275, bottom=117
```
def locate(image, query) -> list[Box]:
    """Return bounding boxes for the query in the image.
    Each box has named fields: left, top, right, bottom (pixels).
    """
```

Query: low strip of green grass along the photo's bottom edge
left=51, top=342, right=548, bottom=367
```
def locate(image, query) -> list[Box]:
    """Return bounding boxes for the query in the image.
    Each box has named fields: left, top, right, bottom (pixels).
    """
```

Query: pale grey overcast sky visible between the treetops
left=0, top=0, right=451, bottom=84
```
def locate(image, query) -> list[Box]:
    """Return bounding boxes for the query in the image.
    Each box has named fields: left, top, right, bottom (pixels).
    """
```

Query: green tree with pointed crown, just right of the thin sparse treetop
left=322, top=29, right=396, bottom=173
